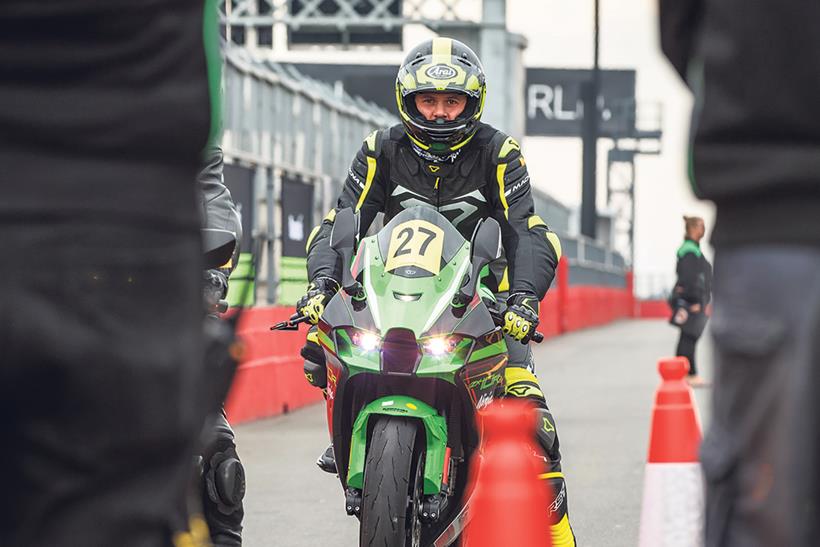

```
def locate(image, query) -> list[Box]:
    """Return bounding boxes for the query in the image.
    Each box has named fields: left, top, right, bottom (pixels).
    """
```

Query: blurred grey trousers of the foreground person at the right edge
left=702, top=246, right=820, bottom=547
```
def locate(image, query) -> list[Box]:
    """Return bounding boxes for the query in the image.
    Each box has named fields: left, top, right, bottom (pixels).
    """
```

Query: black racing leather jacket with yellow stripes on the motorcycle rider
left=308, top=124, right=561, bottom=299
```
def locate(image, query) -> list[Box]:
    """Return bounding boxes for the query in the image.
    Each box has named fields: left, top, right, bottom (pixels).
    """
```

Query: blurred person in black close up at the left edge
left=0, top=0, right=218, bottom=547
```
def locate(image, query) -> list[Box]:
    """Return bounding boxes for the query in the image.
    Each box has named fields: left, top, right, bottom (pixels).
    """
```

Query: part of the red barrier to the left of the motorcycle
left=225, top=307, right=322, bottom=424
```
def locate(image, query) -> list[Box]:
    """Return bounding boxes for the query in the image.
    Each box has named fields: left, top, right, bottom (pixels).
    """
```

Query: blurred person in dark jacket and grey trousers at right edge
left=660, top=0, right=820, bottom=547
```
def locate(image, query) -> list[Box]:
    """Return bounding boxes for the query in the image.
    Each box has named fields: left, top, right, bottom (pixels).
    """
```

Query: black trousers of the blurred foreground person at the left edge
left=0, top=220, right=203, bottom=547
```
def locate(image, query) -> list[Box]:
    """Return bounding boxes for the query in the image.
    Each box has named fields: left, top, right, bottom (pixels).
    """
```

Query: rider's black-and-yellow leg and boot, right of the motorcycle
left=505, top=365, right=575, bottom=547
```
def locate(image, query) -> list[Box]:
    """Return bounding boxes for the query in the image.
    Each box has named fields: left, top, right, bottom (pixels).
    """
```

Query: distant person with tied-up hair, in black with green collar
left=669, top=216, right=712, bottom=387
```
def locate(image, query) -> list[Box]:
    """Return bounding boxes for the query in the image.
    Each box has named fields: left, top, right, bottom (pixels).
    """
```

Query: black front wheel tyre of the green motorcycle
left=359, top=416, right=426, bottom=547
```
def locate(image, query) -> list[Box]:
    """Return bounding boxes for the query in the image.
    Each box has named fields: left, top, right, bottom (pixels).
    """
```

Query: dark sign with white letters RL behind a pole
left=524, top=68, right=635, bottom=137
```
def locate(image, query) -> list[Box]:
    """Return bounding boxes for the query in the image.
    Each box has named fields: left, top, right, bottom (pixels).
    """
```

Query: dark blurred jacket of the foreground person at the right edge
left=660, top=0, right=820, bottom=246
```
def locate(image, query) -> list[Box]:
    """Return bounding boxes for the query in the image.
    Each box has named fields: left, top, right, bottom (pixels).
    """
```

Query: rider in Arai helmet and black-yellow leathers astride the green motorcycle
left=297, top=38, right=575, bottom=547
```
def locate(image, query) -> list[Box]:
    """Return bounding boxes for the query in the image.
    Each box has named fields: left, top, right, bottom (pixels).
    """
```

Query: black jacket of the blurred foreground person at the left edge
left=0, top=0, right=211, bottom=227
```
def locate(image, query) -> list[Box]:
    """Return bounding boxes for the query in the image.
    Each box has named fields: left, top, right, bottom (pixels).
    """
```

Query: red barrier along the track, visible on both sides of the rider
left=225, top=260, right=643, bottom=423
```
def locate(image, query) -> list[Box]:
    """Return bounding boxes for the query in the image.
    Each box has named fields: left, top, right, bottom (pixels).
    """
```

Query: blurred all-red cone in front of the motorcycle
left=464, top=400, right=552, bottom=547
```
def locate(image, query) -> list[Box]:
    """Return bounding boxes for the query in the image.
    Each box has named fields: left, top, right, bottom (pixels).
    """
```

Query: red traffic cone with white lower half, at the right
left=639, top=357, right=703, bottom=547
